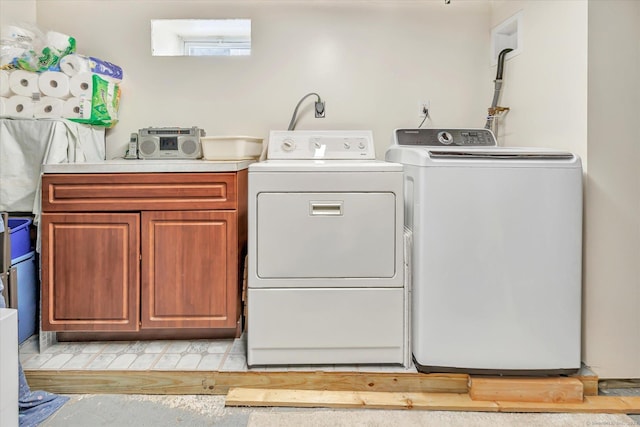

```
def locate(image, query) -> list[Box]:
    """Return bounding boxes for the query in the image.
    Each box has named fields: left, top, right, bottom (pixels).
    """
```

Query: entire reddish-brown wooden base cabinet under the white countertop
left=40, top=170, right=247, bottom=338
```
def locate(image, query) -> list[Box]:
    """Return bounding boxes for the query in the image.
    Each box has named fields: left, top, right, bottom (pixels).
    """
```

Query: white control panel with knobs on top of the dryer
left=267, top=130, right=376, bottom=160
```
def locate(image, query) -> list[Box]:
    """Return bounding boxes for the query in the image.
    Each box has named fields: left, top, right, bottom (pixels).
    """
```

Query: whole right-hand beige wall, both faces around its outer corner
left=491, top=0, right=640, bottom=378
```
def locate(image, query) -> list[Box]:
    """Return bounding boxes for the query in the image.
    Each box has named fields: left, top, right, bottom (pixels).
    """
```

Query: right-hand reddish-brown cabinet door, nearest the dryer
left=141, top=211, right=239, bottom=328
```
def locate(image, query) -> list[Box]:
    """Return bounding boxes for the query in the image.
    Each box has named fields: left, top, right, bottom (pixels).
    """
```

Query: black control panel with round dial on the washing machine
left=395, top=129, right=498, bottom=147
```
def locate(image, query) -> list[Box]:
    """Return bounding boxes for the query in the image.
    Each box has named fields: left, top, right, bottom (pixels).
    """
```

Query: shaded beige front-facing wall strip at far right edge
left=583, top=0, right=640, bottom=378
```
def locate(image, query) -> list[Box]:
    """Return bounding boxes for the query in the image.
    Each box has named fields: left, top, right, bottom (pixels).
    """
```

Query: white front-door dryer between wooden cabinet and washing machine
left=247, top=131, right=410, bottom=366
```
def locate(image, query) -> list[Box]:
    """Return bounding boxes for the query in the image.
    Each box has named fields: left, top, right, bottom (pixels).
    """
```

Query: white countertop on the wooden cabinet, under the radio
left=42, top=159, right=254, bottom=173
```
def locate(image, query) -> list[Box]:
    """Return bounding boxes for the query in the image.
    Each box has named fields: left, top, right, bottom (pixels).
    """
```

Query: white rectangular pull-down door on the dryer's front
left=256, top=192, right=396, bottom=280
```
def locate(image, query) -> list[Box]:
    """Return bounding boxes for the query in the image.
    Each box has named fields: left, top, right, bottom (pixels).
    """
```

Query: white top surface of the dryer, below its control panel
left=249, top=160, right=402, bottom=173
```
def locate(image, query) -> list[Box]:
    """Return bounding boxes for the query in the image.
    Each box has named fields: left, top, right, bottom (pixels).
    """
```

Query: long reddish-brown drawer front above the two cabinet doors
left=42, top=173, right=238, bottom=212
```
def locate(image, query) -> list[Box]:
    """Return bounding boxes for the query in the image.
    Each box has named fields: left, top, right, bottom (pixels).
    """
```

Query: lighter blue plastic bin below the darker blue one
left=11, top=251, right=38, bottom=344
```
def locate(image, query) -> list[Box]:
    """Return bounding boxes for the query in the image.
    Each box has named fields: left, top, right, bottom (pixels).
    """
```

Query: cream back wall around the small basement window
left=26, top=0, right=492, bottom=158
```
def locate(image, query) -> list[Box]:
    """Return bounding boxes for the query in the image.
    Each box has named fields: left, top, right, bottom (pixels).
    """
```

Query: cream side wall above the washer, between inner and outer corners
left=491, top=0, right=589, bottom=169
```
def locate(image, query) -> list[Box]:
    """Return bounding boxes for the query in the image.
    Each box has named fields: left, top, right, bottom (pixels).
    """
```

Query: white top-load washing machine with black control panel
left=386, top=129, right=582, bottom=374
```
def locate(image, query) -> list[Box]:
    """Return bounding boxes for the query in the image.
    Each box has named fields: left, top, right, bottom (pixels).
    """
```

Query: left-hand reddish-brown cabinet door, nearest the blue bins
left=41, top=213, right=140, bottom=331
